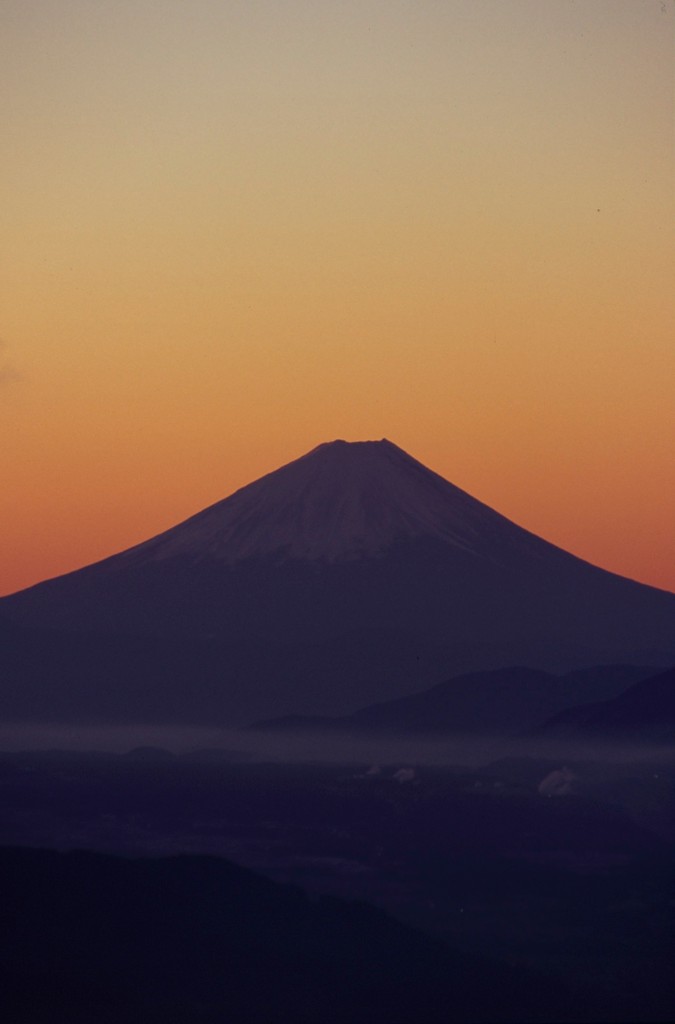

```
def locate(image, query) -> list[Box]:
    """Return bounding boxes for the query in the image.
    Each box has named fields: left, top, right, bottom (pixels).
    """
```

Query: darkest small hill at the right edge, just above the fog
left=538, top=669, right=675, bottom=743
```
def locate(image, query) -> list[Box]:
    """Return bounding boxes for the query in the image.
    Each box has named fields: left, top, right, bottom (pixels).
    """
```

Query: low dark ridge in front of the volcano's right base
left=254, top=665, right=653, bottom=736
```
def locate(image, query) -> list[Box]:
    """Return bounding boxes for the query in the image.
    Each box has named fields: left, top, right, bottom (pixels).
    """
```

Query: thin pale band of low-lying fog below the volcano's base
left=0, top=723, right=675, bottom=767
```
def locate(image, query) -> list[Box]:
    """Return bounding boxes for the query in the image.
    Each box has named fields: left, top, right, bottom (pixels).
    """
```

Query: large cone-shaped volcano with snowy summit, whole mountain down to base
left=0, top=440, right=675, bottom=724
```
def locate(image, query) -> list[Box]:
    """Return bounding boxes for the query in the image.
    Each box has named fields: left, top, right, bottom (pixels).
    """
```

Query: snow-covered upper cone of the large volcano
left=128, top=439, right=512, bottom=564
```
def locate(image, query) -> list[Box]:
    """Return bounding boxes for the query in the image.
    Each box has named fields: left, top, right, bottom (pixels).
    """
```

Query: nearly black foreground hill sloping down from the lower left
left=0, top=849, right=584, bottom=1024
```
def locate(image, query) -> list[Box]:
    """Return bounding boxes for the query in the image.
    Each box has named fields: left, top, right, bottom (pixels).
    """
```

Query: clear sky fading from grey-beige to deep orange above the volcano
left=0, top=0, right=675, bottom=593
